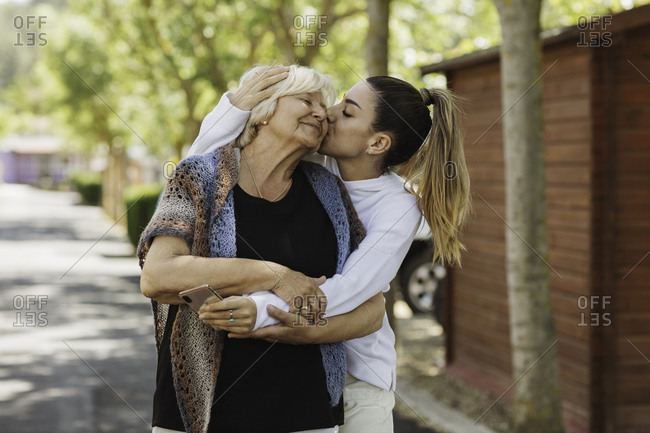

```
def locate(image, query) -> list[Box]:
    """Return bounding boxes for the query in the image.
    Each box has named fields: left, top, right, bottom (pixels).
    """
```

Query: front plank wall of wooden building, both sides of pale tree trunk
left=448, top=40, right=592, bottom=432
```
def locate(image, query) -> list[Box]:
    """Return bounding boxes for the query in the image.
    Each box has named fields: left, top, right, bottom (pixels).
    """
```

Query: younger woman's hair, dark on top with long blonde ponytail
left=366, top=76, right=471, bottom=265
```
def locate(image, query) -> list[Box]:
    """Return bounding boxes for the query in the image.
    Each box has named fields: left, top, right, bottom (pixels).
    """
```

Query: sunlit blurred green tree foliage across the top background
left=0, top=0, right=650, bottom=157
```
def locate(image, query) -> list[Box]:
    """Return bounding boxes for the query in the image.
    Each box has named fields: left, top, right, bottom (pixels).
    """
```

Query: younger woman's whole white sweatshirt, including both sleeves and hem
left=188, top=92, right=422, bottom=389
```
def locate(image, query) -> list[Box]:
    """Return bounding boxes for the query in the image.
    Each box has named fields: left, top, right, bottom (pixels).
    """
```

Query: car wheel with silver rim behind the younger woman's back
left=400, top=246, right=447, bottom=323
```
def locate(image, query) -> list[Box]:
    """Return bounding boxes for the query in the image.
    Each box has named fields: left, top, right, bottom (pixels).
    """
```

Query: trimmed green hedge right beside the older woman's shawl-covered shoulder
left=123, top=185, right=163, bottom=247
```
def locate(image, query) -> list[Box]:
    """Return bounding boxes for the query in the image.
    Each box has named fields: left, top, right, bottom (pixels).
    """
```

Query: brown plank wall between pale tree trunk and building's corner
left=543, top=41, right=600, bottom=432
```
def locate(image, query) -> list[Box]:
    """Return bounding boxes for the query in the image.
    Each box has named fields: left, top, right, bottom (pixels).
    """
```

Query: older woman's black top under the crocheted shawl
left=153, top=169, right=343, bottom=432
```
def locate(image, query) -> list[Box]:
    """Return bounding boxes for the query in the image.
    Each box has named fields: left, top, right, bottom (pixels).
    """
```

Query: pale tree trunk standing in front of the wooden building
left=494, top=0, right=563, bottom=433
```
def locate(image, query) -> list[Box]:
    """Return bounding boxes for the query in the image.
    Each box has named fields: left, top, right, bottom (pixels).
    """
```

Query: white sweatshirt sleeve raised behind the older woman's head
left=187, top=92, right=251, bottom=156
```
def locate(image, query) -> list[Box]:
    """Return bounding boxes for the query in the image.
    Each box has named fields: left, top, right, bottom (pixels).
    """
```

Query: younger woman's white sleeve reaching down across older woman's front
left=320, top=192, right=422, bottom=317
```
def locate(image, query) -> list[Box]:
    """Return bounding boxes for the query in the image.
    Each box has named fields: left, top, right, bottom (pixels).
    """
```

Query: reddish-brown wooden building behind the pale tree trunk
left=422, top=5, right=650, bottom=433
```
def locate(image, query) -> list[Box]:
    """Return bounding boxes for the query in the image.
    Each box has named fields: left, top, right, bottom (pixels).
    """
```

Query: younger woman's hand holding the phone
left=199, top=296, right=257, bottom=333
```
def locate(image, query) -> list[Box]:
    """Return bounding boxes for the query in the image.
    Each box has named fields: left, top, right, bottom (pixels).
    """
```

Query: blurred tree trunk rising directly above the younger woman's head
left=366, top=0, right=390, bottom=76
